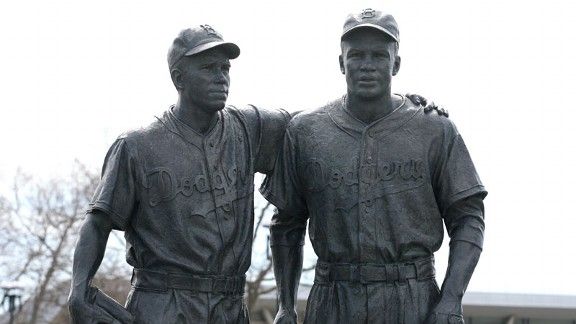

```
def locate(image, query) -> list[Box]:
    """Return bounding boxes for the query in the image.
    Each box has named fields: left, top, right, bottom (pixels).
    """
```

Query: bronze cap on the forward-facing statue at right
left=341, top=8, right=400, bottom=43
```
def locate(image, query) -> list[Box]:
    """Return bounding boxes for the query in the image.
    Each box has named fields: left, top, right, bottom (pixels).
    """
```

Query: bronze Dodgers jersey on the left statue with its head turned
left=88, top=106, right=290, bottom=275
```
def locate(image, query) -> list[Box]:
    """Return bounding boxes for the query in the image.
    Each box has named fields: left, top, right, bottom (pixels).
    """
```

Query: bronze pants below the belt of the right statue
left=304, top=278, right=440, bottom=324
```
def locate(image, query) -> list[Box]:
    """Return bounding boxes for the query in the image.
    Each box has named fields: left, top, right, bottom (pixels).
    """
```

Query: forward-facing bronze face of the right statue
left=340, top=28, right=400, bottom=100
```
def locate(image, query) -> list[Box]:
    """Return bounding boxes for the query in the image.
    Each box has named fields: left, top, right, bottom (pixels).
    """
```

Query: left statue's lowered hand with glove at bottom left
left=68, top=292, right=119, bottom=324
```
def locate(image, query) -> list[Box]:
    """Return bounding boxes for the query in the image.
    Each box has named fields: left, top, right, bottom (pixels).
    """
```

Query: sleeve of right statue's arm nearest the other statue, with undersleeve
left=260, top=131, right=308, bottom=246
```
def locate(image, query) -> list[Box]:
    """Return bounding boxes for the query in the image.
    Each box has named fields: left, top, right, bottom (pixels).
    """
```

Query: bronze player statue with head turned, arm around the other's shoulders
left=69, top=25, right=290, bottom=324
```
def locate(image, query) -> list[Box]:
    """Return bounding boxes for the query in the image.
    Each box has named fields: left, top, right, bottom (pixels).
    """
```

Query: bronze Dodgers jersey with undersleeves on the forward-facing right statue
left=261, top=98, right=486, bottom=264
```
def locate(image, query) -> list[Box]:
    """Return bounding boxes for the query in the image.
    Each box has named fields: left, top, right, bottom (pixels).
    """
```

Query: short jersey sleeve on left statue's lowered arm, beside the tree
left=88, top=138, right=136, bottom=230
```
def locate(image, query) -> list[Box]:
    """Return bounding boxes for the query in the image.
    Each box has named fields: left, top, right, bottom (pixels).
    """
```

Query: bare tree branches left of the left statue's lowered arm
left=0, top=162, right=128, bottom=323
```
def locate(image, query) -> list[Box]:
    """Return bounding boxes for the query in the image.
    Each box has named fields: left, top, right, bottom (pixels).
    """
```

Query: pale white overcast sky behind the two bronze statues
left=0, top=0, right=576, bottom=295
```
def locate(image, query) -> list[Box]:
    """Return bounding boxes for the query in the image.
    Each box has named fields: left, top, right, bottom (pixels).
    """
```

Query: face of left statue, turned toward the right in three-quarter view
left=173, top=47, right=230, bottom=112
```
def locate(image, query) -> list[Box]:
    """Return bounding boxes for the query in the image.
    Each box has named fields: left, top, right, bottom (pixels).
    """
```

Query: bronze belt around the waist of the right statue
left=314, top=256, right=436, bottom=284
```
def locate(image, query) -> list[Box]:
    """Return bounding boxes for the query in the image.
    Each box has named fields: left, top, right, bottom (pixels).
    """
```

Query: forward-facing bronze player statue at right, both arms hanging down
left=261, top=9, right=487, bottom=324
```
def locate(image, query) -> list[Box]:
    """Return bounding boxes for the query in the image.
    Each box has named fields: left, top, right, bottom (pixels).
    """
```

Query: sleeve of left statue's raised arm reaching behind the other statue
left=252, top=106, right=290, bottom=174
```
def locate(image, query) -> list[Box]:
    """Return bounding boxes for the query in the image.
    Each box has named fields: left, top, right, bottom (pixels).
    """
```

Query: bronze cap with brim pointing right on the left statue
left=168, top=25, right=240, bottom=68
